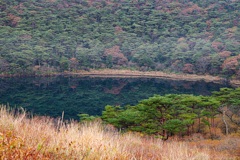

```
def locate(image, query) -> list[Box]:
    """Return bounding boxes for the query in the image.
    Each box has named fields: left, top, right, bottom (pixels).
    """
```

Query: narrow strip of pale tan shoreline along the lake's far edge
left=0, top=69, right=240, bottom=87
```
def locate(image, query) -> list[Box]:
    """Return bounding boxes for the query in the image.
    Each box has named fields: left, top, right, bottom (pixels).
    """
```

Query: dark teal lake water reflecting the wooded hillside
left=0, top=76, right=232, bottom=119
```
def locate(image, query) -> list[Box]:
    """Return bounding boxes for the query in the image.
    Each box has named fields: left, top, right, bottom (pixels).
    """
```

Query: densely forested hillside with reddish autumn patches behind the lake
left=0, top=0, right=240, bottom=79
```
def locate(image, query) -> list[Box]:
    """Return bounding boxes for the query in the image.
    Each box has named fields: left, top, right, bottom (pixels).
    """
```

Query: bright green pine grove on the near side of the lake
left=80, top=88, right=240, bottom=138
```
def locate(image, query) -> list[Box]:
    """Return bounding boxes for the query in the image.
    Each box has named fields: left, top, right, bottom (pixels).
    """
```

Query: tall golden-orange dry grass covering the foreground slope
left=0, top=106, right=238, bottom=160
